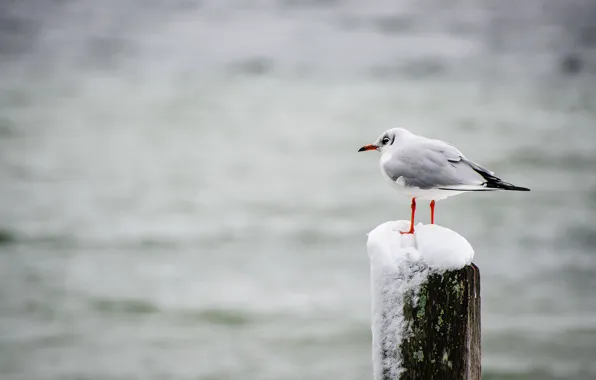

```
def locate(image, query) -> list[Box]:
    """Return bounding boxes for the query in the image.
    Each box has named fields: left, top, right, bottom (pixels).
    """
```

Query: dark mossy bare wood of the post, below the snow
left=396, top=264, right=481, bottom=380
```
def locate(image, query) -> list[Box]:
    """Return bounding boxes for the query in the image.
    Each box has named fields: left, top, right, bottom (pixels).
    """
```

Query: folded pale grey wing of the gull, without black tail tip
left=382, top=140, right=493, bottom=190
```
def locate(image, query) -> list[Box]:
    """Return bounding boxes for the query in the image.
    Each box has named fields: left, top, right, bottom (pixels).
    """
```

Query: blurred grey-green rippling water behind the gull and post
left=0, top=0, right=596, bottom=380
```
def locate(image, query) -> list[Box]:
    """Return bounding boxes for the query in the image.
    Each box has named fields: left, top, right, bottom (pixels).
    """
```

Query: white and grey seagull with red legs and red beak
left=358, top=128, right=530, bottom=234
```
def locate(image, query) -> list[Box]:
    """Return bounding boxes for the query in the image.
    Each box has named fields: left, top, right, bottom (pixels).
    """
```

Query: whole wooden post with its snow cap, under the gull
left=367, top=220, right=480, bottom=380
